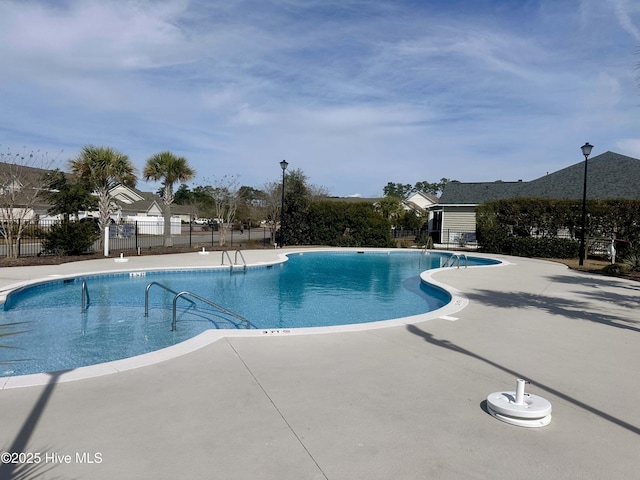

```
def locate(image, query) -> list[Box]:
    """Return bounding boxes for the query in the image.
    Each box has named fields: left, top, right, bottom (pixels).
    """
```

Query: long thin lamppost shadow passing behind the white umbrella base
left=407, top=325, right=640, bottom=435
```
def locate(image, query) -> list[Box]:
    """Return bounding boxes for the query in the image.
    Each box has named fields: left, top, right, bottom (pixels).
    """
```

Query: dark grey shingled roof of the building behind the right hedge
left=440, top=152, right=640, bottom=205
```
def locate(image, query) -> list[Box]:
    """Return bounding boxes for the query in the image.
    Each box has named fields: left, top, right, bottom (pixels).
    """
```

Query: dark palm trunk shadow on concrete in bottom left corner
left=0, top=370, right=71, bottom=480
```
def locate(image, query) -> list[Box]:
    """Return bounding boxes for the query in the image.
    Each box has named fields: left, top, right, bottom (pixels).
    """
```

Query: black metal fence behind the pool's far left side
left=0, top=220, right=271, bottom=257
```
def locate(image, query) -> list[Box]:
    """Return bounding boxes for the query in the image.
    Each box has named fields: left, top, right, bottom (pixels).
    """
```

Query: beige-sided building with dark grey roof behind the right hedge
left=430, top=152, right=640, bottom=243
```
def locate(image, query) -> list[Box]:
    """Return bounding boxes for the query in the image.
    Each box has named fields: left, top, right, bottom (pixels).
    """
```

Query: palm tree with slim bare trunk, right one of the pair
left=142, top=151, right=196, bottom=247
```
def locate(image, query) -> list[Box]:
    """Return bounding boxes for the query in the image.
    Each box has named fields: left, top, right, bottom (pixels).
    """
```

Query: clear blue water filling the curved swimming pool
left=0, top=251, right=497, bottom=376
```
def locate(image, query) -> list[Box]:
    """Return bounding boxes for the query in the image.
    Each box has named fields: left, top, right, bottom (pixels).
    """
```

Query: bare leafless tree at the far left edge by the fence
left=0, top=150, right=53, bottom=258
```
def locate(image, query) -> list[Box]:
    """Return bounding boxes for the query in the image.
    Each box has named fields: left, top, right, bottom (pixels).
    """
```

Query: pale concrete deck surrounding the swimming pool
left=0, top=250, right=640, bottom=480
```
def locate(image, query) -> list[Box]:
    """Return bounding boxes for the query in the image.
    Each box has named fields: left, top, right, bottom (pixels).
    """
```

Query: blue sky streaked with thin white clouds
left=0, top=0, right=640, bottom=197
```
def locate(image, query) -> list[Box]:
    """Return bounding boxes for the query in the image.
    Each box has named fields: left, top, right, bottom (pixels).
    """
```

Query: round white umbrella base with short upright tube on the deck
left=487, top=378, right=551, bottom=427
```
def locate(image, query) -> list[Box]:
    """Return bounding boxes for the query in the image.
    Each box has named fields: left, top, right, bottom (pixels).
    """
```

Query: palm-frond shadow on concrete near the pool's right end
left=465, top=282, right=640, bottom=332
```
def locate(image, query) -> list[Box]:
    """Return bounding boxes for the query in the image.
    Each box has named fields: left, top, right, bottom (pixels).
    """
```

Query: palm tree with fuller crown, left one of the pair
left=69, top=145, right=137, bottom=242
